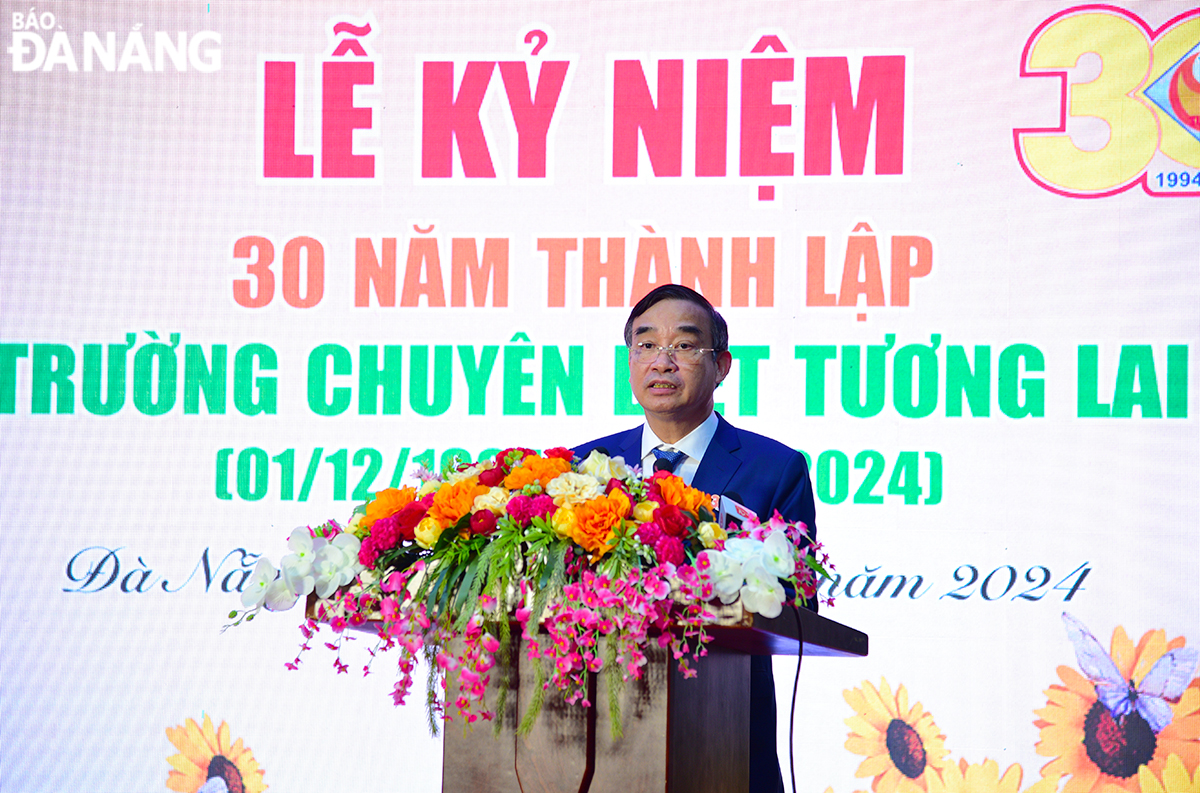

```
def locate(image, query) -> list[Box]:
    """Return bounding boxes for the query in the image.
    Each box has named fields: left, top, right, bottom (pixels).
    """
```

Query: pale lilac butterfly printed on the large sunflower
left=1062, top=612, right=1200, bottom=735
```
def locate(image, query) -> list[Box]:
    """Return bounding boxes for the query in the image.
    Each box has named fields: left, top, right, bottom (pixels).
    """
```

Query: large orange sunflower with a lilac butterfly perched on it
left=1033, top=625, right=1200, bottom=793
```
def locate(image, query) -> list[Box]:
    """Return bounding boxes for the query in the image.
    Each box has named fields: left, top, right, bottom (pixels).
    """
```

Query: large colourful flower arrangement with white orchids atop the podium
left=229, top=449, right=828, bottom=733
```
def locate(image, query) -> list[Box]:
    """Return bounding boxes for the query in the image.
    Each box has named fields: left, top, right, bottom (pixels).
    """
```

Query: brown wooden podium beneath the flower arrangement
left=442, top=609, right=866, bottom=793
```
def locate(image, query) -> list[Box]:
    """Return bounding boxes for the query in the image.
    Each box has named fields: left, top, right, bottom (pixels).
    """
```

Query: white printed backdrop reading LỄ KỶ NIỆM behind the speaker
left=0, top=0, right=1200, bottom=793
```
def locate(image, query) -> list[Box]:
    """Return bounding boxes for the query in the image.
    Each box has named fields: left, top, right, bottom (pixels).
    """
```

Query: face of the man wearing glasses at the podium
left=629, top=300, right=731, bottom=431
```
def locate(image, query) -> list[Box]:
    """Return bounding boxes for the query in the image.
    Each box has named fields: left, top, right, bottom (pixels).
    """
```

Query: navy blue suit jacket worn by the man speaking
left=575, top=413, right=817, bottom=793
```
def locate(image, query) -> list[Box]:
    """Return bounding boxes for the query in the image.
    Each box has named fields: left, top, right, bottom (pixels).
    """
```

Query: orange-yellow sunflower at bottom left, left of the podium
left=167, top=714, right=266, bottom=793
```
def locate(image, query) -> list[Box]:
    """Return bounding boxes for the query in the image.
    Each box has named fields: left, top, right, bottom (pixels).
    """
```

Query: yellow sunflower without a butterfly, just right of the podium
left=842, top=679, right=946, bottom=793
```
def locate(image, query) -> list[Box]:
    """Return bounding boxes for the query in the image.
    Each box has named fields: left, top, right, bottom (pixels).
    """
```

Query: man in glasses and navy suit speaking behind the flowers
left=575, top=284, right=816, bottom=793
